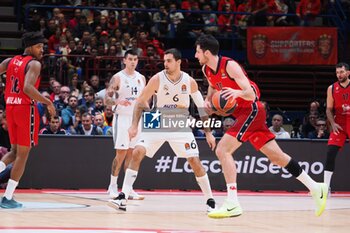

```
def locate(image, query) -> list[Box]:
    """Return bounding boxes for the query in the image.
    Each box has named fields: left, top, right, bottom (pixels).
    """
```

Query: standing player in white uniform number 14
left=105, top=50, right=146, bottom=200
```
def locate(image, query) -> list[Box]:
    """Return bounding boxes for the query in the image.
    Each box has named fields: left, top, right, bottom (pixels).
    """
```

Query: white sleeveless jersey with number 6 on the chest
left=156, top=70, right=191, bottom=115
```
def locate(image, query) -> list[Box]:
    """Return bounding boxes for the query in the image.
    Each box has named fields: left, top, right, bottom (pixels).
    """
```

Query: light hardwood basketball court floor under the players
left=0, top=190, right=350, bottom=233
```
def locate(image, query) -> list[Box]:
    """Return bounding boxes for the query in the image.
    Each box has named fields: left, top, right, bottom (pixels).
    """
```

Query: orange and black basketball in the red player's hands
left=211, top=91, right=236, bottom=115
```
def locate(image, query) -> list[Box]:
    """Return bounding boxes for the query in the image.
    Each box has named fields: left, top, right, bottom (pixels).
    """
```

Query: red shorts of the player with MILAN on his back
left=6, top=105, right=40, bottom=147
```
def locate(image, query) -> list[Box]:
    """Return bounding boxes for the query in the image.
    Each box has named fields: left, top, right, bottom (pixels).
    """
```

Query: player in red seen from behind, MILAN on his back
left=0, top=32, right=56, bottom=209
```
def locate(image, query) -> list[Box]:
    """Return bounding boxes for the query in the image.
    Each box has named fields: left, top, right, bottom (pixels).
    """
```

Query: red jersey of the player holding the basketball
left=204, top=56, right=260, bottom=106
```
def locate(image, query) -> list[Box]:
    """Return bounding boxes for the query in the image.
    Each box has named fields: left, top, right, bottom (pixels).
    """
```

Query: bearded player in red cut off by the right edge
left=323, top=63, right=350, bottom=194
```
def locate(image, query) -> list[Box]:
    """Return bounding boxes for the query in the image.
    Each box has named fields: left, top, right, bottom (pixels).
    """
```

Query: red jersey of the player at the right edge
left=332, top=82, right=350, bottom=123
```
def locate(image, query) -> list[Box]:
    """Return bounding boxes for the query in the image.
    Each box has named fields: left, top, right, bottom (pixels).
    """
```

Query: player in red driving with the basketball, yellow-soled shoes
left=195, top=35, right=328, bottom=218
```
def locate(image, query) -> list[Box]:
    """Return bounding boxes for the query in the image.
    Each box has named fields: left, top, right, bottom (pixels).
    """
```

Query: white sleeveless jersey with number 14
left=116, top=70, right=145, bottom=115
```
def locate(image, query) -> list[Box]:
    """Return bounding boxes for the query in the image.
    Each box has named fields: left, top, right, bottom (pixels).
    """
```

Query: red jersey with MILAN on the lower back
left=5, top=55, right=40, bottom=105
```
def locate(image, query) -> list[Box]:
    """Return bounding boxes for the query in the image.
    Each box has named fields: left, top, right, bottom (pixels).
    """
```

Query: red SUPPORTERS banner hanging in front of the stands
left=247, top=27, right=338, bottom=65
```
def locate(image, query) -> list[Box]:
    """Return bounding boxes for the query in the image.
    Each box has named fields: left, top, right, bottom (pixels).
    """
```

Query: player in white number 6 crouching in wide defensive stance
left=109, top=49, right=216, bottom=211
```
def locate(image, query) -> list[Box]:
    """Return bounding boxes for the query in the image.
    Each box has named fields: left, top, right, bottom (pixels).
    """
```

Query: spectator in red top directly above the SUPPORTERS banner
left=296, top=0, right=321, bottom=26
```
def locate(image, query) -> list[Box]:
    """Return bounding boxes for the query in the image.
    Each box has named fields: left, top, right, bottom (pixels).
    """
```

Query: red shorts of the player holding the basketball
left=226, top=101, right=275, bottom=150
